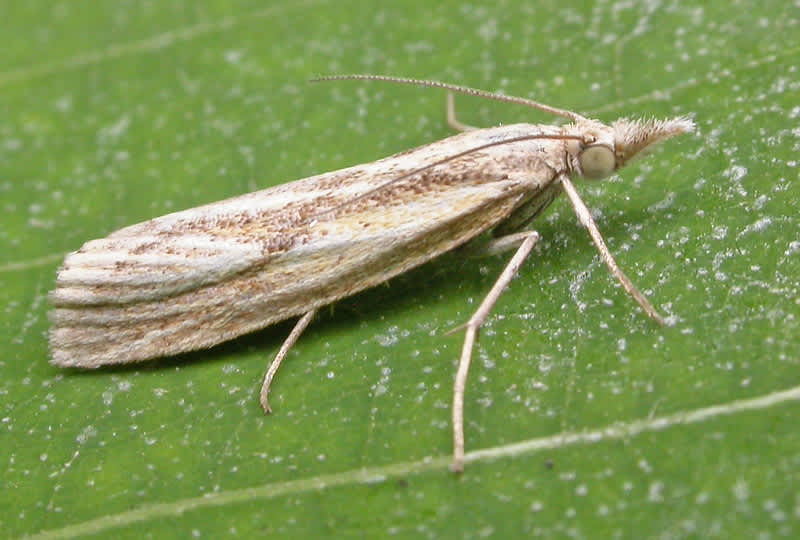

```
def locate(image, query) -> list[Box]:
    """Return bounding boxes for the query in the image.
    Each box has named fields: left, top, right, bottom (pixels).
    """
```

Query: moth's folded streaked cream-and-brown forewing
left=50, top=124, right=560, bottom=367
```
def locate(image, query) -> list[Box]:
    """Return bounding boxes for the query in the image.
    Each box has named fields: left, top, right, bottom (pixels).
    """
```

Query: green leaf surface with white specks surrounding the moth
left=0, top=0, right=800, bottom=538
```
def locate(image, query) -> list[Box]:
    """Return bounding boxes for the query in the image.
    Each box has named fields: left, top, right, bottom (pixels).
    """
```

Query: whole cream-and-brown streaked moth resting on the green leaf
left=49, top=75, right=694, bottom=471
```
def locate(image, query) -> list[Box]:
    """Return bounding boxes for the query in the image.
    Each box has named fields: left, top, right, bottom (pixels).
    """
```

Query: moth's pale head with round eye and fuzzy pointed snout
left=577, top=116, right=694, bottom=180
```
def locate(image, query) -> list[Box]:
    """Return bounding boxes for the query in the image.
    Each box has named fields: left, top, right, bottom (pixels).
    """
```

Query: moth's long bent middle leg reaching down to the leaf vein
left=452, top=231, right=539, bottom=472
